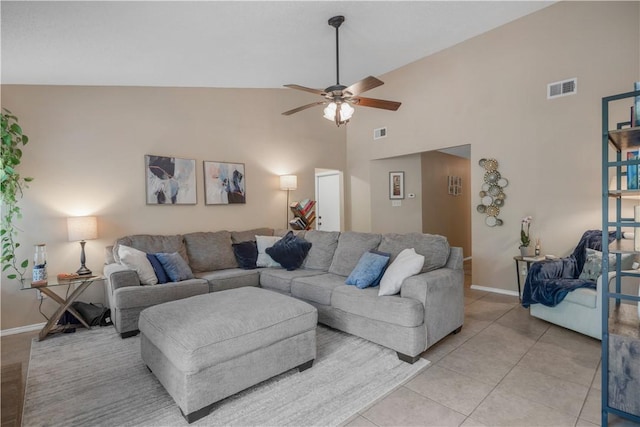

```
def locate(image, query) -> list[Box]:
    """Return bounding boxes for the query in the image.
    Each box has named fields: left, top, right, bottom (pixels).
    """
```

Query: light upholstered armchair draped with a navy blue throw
left=522, top=230, right=637, bottom=339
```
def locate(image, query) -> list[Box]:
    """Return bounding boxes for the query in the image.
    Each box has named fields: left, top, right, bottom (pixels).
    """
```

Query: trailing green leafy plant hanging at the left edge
left=0, top=108, right=33, bottom=280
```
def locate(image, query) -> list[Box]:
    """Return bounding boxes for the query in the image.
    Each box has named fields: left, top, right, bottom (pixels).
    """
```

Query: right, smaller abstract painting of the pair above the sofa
left=203, top=161, right=247, bottom=205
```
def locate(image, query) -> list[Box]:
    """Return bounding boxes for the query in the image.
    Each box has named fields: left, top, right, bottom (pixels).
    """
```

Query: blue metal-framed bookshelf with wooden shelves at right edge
left=601, top=86, right=640, bottom=427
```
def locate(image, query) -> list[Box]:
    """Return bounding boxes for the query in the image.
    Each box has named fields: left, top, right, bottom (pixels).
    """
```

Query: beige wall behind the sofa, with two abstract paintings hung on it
left=1, top=86, right=346, bottom=329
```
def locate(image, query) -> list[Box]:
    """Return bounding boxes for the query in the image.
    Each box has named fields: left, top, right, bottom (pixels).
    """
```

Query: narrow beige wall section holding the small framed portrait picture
left=370, top=155, right=422, bottom=233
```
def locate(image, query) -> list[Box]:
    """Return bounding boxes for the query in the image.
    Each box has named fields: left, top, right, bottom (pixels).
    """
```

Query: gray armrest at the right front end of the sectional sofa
left=400, top=268, right=464, bottom=347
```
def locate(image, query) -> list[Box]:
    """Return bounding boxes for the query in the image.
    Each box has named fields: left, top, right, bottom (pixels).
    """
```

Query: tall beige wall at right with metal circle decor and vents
left=347, top=2, right=640, bottom=291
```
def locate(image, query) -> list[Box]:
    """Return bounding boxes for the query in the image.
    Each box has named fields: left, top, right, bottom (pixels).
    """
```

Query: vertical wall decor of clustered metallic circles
left=476, top=159, right=509, bottom=227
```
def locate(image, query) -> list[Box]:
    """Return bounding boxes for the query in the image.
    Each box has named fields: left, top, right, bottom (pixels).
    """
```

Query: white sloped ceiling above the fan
left=0, top=0, right=553, bottom=88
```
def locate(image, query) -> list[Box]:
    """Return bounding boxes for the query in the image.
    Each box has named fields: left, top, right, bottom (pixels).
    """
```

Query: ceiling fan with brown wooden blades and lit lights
left=282, top=16, right=401, bottom=126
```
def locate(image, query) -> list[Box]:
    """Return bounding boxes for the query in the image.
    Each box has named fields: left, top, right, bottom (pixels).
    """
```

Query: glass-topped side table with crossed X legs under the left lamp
left=20, top=275, right=104, bottom=341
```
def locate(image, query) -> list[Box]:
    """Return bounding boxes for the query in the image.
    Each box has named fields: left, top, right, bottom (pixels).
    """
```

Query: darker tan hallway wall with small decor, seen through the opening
left=421, top=151, right=472, bottom=258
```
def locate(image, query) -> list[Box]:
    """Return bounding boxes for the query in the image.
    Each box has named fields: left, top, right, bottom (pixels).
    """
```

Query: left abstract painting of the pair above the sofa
left=144, top=155, right=197, bottom=205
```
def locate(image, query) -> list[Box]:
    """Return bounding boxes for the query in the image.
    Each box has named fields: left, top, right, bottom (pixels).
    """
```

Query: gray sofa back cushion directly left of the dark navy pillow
left=184, top=230, right=238, bottom=272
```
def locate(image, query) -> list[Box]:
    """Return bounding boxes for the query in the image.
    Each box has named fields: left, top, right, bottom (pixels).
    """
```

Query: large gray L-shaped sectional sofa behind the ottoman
left=104, top=228, right=464, bottom=363
